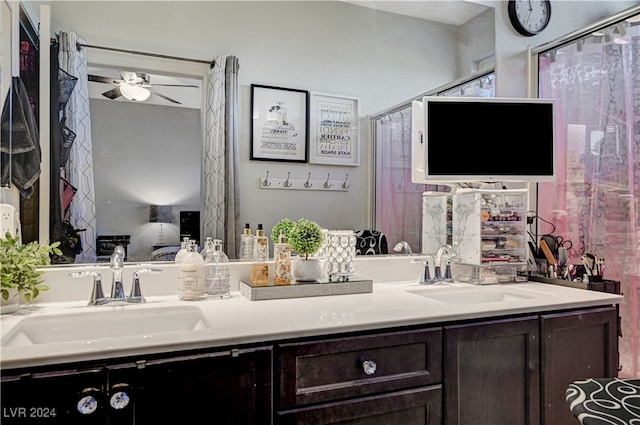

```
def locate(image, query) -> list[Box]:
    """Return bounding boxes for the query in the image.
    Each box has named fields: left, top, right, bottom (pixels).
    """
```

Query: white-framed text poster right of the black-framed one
left=309, top=93, right=360, bottom=165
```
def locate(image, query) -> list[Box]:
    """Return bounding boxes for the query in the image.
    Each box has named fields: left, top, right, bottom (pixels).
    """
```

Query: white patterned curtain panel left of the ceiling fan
left=58, top=31, right=96, bottom=263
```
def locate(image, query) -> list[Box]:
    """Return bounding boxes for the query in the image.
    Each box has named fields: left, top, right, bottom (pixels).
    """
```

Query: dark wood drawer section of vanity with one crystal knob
left=276, top=328, right=442, bottom=425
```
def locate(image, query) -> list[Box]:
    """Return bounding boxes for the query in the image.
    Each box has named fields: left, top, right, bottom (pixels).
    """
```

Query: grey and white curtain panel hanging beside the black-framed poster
left=201, top=56, right=241, bottom=258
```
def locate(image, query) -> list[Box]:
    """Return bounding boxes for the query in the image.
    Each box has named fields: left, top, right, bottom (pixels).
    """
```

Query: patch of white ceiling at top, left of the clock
left=344, top=0, right=500, bottom=26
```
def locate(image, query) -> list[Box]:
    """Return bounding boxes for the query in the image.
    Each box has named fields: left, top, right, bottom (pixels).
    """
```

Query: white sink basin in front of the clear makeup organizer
left=407, top=286, right=544, bottom=304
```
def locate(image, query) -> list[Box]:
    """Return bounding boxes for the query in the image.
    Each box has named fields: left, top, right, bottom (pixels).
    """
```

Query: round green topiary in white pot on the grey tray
left=287, top=218, right=325, bottom=282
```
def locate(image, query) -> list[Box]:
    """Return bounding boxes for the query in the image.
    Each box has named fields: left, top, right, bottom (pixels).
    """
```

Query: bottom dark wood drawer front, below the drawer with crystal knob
left=277, top=385, right=442, bottom=425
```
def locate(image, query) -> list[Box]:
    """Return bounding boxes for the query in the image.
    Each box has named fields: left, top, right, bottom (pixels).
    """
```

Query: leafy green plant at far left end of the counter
left=0, top=232, right=62, bottom=312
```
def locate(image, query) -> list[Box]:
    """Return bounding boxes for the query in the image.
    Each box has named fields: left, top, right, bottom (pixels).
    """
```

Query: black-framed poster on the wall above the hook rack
left=251, top=84, right=309, bottom=162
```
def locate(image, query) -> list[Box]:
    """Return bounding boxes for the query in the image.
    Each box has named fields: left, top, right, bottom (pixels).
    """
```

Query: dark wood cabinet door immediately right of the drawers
left=444, top=316, right=540, bottom=425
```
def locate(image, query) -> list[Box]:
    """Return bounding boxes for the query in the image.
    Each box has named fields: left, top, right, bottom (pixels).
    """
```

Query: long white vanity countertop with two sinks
left=0, top=274, right=623, bottom=370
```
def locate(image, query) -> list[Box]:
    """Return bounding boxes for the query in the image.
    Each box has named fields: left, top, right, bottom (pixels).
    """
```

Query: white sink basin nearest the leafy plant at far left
left=0, top=307, right=210, bottom=347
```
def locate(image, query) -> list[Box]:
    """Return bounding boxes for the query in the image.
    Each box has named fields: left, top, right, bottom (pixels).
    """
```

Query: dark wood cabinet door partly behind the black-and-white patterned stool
left=541, top=307, right=618, bottom=425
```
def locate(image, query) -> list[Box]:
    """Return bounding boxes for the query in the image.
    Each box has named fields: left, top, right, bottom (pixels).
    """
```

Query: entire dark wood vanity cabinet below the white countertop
left=1, top=306, right=618, bottom=425
